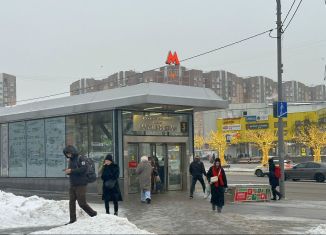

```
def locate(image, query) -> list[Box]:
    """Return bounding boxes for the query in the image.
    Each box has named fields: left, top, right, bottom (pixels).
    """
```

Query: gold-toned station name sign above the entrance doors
left=133, top=115, right=188, bottom=133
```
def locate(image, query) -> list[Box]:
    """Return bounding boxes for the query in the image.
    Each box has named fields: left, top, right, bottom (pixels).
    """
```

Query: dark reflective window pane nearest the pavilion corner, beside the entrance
left=88, top=112, right=113, bottom=174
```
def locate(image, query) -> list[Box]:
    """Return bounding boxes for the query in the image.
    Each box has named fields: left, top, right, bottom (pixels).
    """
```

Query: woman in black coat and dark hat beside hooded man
left=101, top=154, right=122, bottom=215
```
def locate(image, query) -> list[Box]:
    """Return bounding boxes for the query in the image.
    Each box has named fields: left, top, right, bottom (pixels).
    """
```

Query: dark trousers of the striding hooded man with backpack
left=69, top=185, right=96, bottom=221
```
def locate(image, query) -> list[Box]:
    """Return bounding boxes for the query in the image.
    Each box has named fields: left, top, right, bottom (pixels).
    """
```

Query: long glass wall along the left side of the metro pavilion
left=0, top=111, right=114, bottom=177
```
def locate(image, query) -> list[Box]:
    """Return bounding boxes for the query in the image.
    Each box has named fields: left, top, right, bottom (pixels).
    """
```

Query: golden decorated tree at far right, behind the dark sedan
left=294, top=124, right=326, bottom=162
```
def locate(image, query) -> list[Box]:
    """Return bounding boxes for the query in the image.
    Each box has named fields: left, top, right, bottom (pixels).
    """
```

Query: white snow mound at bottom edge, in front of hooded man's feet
left=32, top=214, right=150, bottom=234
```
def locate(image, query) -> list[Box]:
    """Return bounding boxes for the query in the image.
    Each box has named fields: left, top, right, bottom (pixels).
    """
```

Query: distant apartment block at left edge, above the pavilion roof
left=0, top=73, right=16, bottom=107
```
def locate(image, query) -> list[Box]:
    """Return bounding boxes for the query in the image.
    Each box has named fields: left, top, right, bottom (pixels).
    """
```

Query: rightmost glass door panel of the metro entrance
left=167, top=144, right=182, bottom=190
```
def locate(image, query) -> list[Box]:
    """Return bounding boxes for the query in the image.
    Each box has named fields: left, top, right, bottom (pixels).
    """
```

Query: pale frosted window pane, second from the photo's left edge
left=9, top=122, right=26, bottom=177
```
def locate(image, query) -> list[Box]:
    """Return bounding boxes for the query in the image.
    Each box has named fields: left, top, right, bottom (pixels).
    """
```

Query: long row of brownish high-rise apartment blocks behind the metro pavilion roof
left=70, top=65, right=326, bottom=104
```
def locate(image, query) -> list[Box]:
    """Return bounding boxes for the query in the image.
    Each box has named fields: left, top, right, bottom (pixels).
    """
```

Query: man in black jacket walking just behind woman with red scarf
left=189, top=155, right=206, bottom=199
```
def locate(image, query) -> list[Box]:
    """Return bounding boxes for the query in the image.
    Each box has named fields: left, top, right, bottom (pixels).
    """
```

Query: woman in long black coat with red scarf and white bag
left=207, top=158, right=228, bottom=213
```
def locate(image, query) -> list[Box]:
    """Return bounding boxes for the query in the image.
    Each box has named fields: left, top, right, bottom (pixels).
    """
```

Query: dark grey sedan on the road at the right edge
left=284, top=162, right=326, bottom=182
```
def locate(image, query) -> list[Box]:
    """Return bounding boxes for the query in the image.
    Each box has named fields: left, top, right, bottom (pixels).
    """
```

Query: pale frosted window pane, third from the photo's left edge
left=26, top=119, right=45, bottom=177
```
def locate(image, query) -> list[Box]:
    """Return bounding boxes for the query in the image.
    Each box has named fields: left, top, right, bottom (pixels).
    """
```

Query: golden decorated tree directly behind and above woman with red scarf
left=207, top=131, right=237, bottom=166
